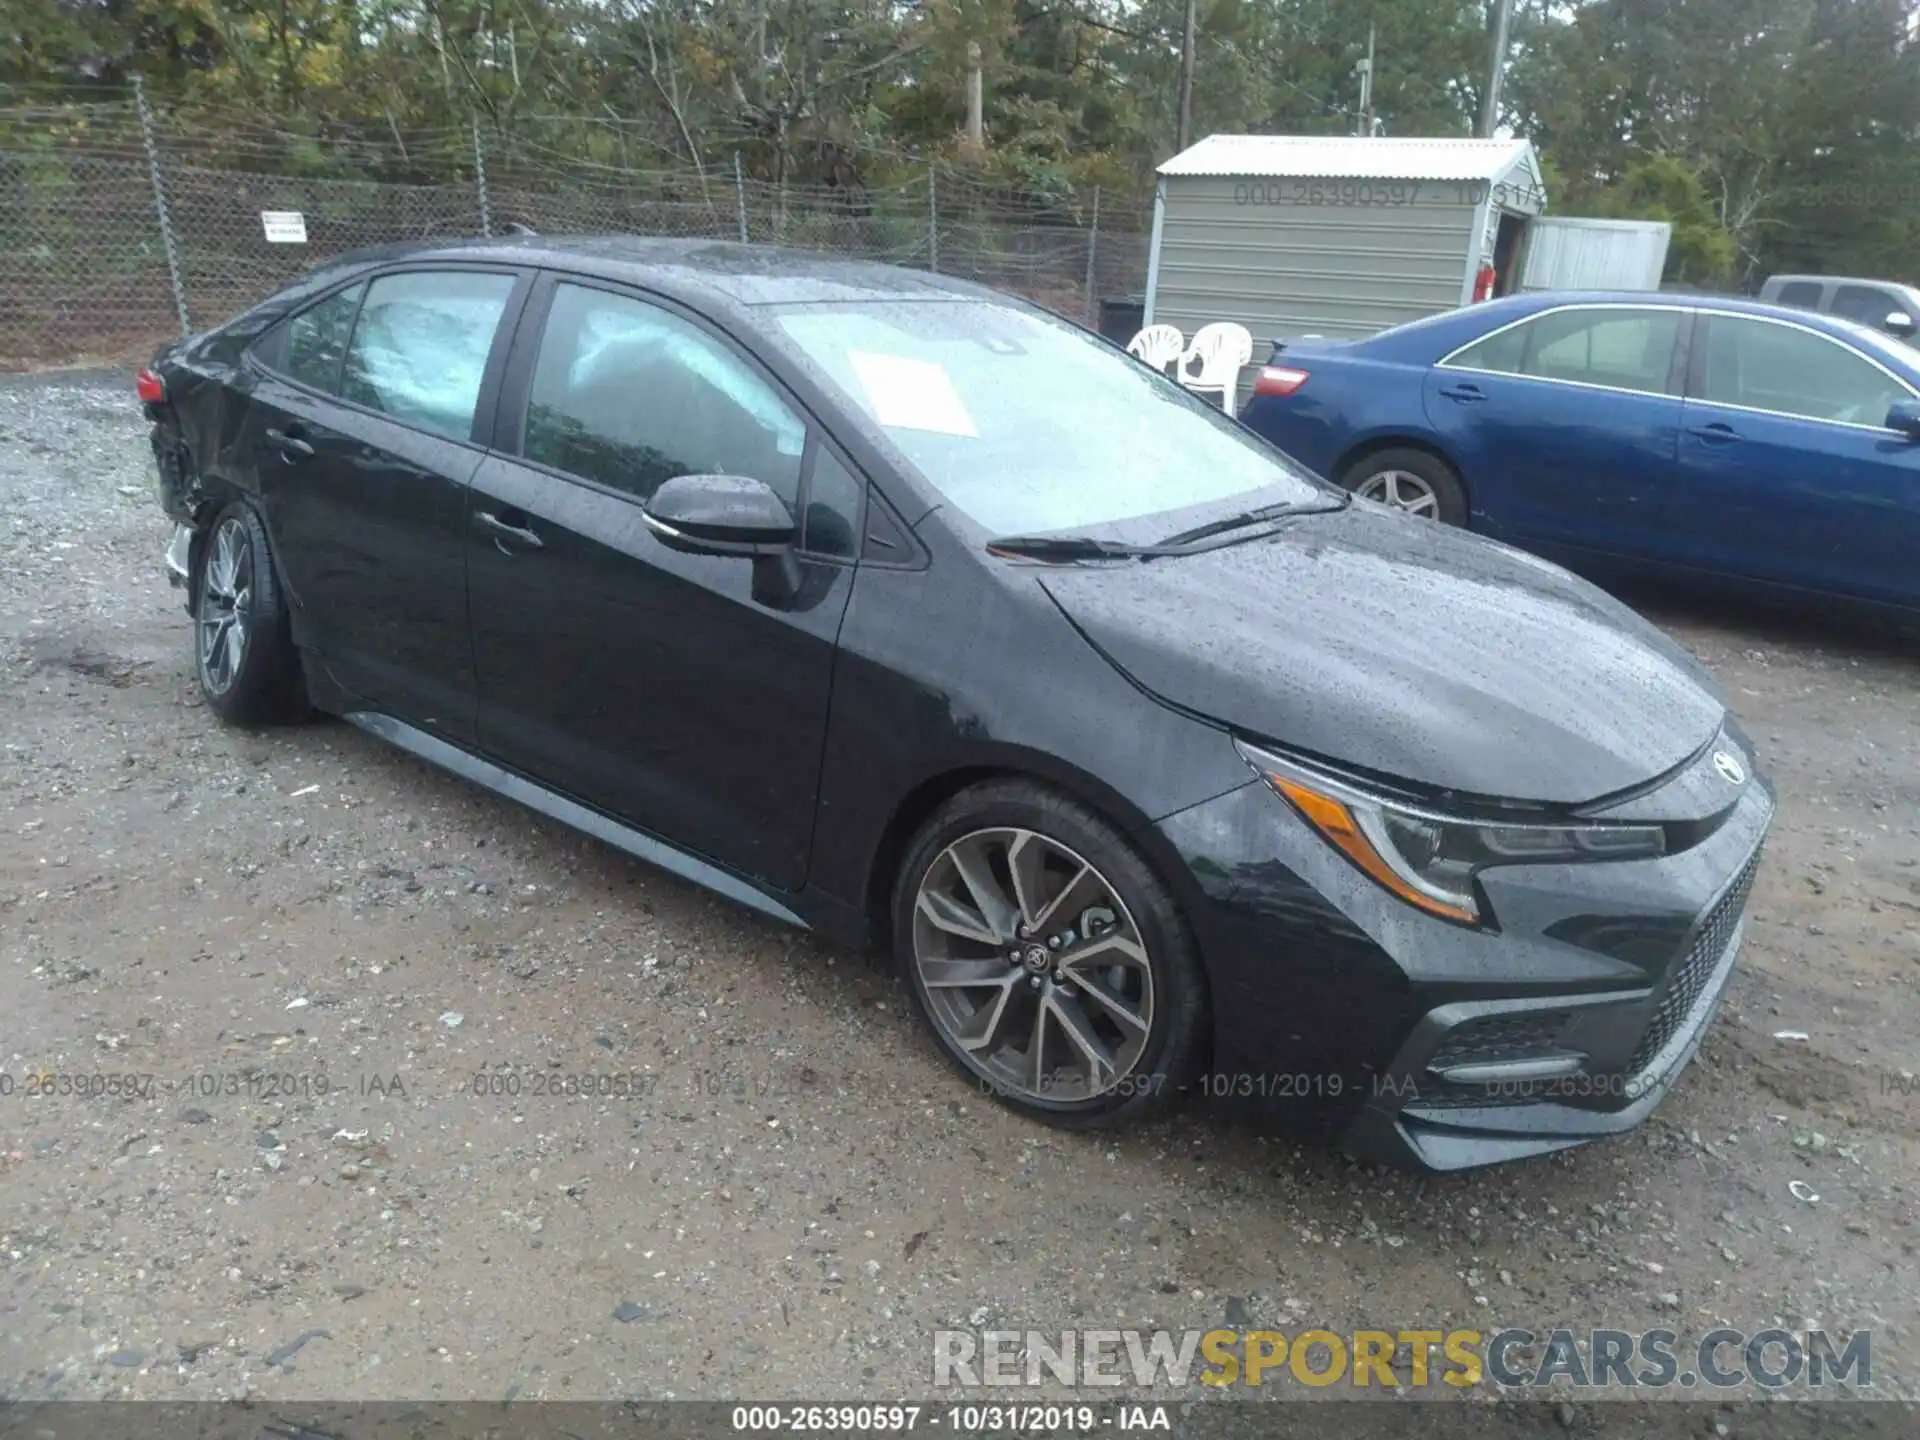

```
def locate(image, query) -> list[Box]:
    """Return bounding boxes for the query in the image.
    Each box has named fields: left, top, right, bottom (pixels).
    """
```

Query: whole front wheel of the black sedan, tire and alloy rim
left=893, top=778, right=1208, bottom=1129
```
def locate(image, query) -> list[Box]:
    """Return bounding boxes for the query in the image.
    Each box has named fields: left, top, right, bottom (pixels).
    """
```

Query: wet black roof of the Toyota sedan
left=320, top=234, right=1018, bottom=307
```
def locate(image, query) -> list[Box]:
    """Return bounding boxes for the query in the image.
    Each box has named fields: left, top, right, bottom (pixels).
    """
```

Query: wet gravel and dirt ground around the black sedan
left=0, top=374, right=1920, bottom=1432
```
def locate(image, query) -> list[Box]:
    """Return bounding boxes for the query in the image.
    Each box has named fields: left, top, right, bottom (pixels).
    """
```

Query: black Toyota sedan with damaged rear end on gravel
left=140, top=238, right=1772, bottom=1169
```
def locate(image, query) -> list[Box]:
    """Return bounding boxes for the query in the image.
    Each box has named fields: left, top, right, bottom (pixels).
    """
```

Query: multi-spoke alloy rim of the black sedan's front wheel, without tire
left=914, top=828, right=1154, bottom=1104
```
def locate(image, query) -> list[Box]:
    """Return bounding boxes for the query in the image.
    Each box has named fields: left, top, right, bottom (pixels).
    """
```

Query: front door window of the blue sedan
left=1695, top=315, right=1912, bottom=426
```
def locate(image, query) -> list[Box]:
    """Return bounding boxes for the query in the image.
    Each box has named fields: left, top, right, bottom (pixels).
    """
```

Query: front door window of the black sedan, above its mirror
left=522, top=284, right=806, bottom=509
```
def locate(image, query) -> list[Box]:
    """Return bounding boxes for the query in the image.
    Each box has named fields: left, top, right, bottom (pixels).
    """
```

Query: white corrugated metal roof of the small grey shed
left=1160, top=134, right=1538, bottom=182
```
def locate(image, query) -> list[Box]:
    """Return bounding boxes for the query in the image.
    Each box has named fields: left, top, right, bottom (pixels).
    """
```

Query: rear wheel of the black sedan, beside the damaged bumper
left=194, top=501, right=311, bottom=726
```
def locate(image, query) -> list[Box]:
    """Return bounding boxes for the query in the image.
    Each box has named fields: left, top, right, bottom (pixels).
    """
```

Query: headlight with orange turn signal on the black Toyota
left=1235, top=741, right=1667, bottom=925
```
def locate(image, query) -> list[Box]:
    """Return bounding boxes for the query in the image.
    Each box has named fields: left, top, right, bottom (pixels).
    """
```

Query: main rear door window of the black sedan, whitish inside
left=340, top=271, right=515, bottom=440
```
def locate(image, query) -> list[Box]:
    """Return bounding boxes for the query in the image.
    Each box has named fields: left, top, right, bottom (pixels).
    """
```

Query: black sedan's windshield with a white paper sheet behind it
left=780, top=300, right=1327, bottom=536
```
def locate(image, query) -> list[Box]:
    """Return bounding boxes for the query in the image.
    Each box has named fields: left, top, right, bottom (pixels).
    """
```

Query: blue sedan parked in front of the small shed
left=1240, top=294, right=1920, bottom=612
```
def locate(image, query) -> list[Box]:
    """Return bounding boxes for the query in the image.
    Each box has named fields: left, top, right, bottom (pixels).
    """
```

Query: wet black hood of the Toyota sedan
left=1041, top=501, right=1726, bottom=804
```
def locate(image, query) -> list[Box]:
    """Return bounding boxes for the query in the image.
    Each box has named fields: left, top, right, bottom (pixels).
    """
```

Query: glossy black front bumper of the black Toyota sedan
left=1160, top=733, right=1774, bottom=1169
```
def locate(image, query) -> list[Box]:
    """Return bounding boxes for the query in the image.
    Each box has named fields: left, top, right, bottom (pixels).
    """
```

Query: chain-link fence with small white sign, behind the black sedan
left=0, top=96, right=1148, bottom=369
